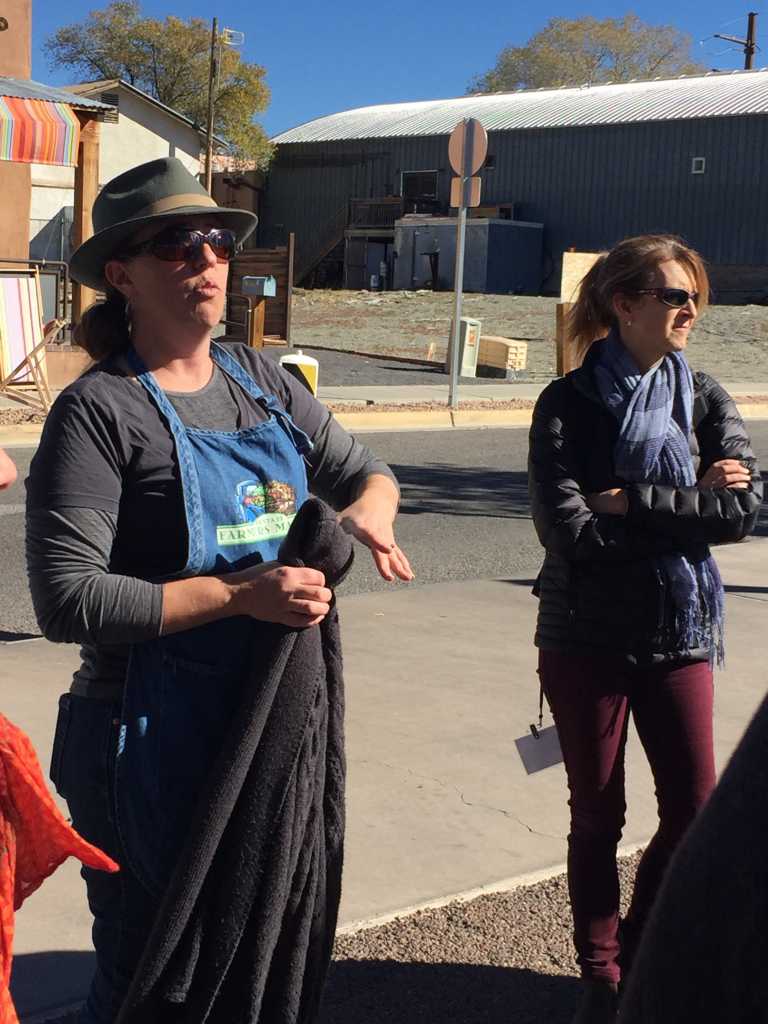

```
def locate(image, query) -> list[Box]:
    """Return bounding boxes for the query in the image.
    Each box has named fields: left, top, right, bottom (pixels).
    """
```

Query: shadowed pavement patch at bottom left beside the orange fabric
left=10, top=950, right=95, bottom=1018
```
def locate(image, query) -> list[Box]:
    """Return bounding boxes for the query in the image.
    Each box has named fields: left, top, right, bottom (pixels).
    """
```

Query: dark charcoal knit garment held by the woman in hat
left=118, top=499, right=352, bottom=1024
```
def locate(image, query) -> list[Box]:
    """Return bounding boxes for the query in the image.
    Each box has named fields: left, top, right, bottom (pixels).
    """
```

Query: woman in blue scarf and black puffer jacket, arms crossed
left=529, top=236, right=762, bottom=1024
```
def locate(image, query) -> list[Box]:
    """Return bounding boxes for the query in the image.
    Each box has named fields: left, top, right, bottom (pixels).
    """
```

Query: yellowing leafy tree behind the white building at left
left=44, top=0, right=271, bottom=165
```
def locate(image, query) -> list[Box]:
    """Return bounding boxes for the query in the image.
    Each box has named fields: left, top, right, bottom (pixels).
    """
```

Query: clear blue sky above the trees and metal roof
left=32, top=0, right=768, bottom=135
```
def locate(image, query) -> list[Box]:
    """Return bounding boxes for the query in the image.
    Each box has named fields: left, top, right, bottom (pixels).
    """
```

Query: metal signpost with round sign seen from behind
left=449, top=118, right=488, bottom=409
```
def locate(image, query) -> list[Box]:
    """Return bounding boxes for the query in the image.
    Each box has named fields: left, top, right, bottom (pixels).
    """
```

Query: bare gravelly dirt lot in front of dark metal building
left=292, top=289, right=768, bottom=383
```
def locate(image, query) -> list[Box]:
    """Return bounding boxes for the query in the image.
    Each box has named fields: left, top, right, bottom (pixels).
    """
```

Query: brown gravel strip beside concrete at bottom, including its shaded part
left=322, top=854, right=640, bottom=1024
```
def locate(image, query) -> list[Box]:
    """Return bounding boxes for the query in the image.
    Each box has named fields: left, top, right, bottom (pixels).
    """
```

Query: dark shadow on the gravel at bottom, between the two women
left=321, top=959, right=580, bottom=1024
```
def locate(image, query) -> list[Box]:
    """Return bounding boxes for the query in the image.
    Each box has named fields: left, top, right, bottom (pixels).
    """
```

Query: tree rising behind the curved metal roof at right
left=469, top=14, right=707, bottom=92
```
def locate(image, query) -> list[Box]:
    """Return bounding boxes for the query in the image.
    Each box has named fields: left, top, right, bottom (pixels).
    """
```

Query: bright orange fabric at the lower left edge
left=0, top=715, right=119, bottom=1024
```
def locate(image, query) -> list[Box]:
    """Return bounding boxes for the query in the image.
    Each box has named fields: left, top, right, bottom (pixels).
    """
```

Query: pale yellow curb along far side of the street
left=0, top=401, right=768, bottom=449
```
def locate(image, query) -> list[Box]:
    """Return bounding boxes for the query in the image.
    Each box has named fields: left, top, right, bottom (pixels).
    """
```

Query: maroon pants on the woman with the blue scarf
left=539, top=650, right=715, bottom=982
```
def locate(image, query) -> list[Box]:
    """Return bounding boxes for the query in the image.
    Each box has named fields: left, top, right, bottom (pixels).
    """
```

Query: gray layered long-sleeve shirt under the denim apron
left=27, top=345, right=394, bottom=697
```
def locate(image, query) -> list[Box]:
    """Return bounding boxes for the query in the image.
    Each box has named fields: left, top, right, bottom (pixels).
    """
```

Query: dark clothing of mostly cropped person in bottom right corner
left=621, top=698, right=768, bottom=1024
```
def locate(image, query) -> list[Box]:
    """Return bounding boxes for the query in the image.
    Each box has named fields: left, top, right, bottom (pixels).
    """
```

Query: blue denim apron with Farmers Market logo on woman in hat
left=116, top=344, right=311, bottom=892
